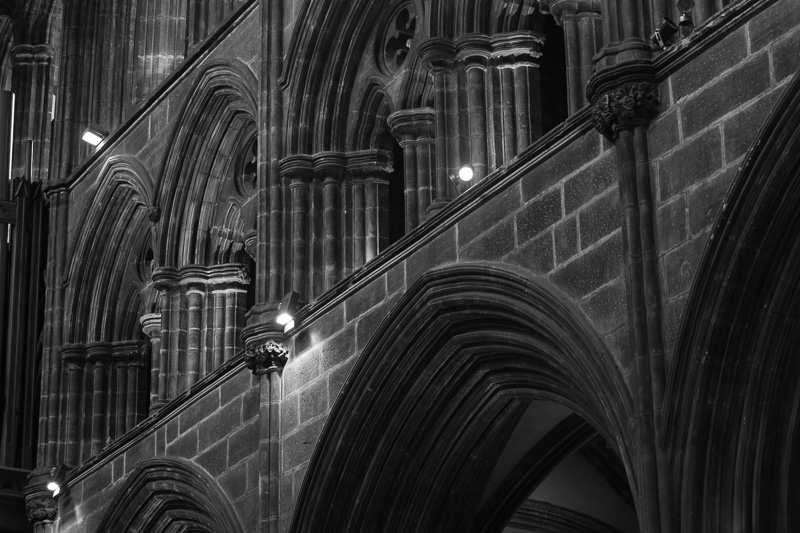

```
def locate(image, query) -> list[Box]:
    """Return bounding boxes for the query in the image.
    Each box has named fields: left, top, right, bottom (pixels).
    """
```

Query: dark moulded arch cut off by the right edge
left=665, top=72, right=800, bottom=532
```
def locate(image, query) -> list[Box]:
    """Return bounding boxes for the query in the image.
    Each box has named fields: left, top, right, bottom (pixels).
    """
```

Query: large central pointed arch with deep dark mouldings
left=290, top=265, right=635, bottom=532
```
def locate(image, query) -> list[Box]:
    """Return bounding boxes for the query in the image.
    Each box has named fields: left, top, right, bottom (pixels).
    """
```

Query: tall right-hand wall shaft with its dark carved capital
left=590, top=78, right=673, bottom=532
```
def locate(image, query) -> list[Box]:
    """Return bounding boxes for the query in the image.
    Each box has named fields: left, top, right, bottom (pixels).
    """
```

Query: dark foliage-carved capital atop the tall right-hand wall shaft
left=592, top=82, right=660, bottom=139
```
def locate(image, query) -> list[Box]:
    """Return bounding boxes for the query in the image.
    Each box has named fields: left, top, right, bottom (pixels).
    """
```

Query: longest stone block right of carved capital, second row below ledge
left=681, top=52, right=770, bottom=137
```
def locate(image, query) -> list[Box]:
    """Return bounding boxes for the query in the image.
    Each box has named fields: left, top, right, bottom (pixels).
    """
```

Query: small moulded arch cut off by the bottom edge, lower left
left=97, top=459, right=243, bottom=533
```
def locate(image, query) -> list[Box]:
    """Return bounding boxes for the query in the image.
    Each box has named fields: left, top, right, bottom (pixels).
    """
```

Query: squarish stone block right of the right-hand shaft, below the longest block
left=658, top=128, right=722, bottom=202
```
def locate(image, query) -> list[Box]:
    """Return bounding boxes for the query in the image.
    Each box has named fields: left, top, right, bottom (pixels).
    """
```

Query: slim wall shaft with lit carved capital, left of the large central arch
left=245, top=337, right=289, bottom=533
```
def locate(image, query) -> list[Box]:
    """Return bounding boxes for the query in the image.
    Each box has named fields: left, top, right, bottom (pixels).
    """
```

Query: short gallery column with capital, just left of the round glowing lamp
left=388, top=107, right=437, bottom=229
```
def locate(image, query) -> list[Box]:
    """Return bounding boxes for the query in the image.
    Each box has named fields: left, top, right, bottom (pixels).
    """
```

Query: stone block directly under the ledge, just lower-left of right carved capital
left=522, top=130, right=601, bottom=202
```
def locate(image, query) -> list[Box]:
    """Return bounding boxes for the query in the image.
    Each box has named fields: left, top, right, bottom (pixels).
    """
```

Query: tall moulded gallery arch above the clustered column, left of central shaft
left=156, top=61, right=258, bottom=266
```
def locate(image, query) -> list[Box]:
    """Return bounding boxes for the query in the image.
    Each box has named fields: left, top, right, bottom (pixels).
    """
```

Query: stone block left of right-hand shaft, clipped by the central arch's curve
left=550, top=232, right=622, bottom=300
